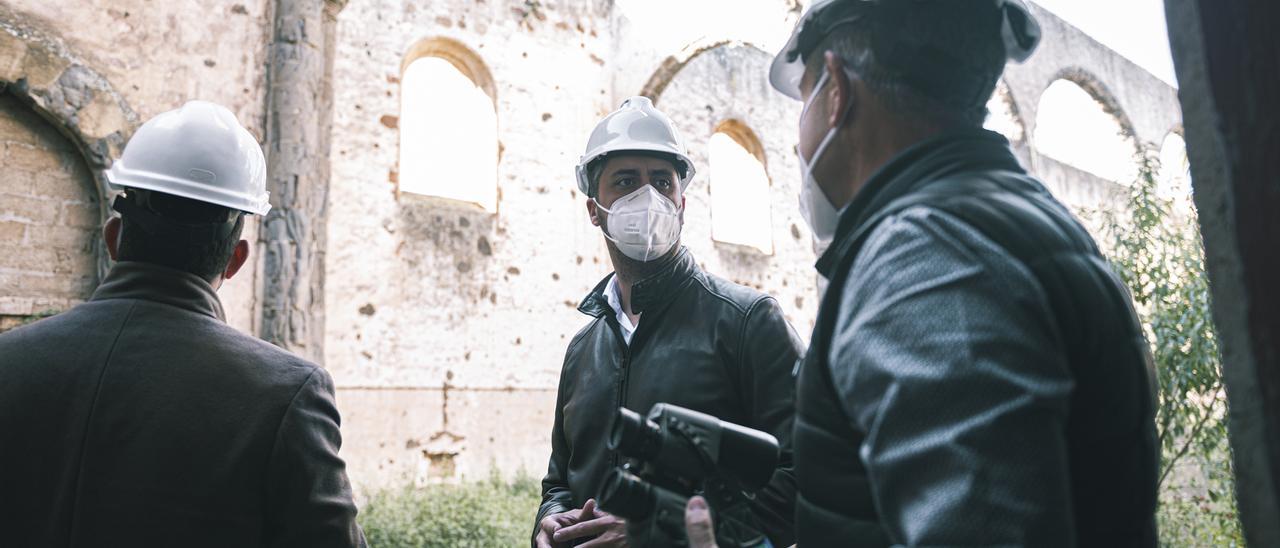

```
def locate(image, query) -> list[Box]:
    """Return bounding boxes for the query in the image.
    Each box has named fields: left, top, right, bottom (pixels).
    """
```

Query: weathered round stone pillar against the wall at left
left=259, top=0, right=347, bottom=364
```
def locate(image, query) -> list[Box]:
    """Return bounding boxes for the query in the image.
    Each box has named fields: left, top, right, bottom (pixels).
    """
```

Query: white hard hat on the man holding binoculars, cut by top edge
left=769, top=0, right=1041, bottom=101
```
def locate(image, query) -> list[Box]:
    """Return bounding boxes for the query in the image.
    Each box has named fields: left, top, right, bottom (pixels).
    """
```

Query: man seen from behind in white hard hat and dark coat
left=0, top=101, right=365, bottom=547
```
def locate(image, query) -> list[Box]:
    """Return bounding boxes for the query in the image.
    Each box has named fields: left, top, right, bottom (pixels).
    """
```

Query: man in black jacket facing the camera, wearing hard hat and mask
left=534, top=97, right=800, bottom=548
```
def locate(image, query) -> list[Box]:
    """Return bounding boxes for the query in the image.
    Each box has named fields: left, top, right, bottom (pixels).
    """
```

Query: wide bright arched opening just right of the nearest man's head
left=1036, top=79, right=1138, bottom=184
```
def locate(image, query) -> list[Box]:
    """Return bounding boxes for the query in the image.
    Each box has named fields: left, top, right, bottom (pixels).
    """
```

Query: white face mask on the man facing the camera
left=591, top=184, right=681, bottom=261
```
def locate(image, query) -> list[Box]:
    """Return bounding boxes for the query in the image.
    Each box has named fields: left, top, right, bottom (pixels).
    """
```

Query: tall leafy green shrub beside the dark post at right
left=1101, top=148, right=1244, bottom=545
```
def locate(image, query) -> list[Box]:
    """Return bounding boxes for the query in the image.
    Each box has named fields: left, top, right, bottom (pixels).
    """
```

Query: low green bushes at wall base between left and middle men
left=360, top=472, right=541, bottom=548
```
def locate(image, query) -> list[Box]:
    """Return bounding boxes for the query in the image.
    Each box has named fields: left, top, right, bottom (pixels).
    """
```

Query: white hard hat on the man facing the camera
left=577, top=96, right=694, bottom=196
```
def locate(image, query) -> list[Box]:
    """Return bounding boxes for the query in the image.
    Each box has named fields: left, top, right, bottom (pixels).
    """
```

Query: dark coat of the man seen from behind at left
left=0, top=262, right=364, bottom=547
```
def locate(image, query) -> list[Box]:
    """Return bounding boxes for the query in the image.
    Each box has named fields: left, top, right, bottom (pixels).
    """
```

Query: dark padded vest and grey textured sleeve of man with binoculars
left=795, top=131, right=1158, bottom=547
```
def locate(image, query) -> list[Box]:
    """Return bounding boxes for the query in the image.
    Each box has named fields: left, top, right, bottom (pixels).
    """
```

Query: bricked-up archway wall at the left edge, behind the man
left=0, top=93, right=100, bottom=330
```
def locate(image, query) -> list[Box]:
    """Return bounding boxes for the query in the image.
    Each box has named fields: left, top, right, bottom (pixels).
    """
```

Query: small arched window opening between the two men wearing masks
left=709, top=120, right=773, bottom=255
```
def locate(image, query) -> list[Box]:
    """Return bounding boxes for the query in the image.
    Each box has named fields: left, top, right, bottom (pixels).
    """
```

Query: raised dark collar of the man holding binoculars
left=817, top=129, right=1027, bottom=278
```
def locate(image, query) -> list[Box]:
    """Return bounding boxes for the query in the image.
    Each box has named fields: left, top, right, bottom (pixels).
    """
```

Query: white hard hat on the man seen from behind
left=106, top=101, right=271, bottom=215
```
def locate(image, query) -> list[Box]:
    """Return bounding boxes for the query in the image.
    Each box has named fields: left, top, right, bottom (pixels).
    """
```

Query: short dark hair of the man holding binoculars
left=804, top=0, right=1006, bottom=127
